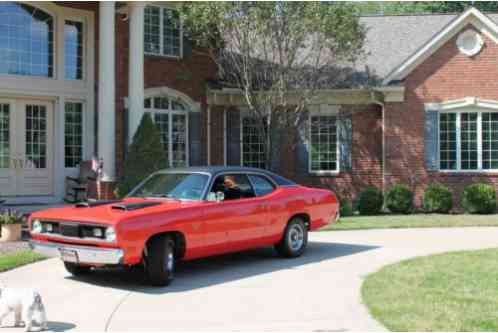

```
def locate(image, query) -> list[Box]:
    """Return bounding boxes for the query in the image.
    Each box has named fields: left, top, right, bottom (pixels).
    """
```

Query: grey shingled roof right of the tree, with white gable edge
left=355, top=8, right=498, bottom=84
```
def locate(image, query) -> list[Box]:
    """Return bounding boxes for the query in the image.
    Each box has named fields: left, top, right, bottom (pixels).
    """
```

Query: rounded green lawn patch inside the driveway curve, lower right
left=362, top=249, right=498, bottom=331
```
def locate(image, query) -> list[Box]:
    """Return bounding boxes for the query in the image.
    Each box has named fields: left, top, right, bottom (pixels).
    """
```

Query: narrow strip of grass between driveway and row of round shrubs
left=320, top=214, right=498, bottom=231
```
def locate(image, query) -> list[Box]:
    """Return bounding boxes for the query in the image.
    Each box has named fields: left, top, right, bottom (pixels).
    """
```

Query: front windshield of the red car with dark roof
left=128, top=173, right=209, bottom=200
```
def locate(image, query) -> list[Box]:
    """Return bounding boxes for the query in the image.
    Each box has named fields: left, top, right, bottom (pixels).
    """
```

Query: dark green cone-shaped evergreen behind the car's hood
left=117, top=113, right=168, bottom=197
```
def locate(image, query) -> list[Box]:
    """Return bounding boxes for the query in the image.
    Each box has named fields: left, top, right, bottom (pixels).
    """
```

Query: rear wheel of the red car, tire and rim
left=275, top=217, right=308, bottom=258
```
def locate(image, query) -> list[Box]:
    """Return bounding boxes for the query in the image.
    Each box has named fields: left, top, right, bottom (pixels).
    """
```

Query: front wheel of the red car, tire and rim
left=145, top=236, right=175, bottom=287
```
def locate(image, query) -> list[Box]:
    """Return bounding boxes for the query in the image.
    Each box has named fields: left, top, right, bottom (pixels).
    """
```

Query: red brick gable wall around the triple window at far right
left=386, top=27, right=498, bottom=205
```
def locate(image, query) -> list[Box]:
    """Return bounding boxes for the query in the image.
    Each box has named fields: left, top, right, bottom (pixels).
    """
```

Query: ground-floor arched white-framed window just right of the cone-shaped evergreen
left=144, top=96, right=189, bottom=167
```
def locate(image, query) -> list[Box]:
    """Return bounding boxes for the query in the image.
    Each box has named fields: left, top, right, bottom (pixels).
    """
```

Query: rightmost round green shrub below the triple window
left=462, top=183, right=496, bottom=214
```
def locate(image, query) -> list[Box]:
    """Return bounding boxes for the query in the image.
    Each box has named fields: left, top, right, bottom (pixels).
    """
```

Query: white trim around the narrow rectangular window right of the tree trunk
left=308, top=104, right=341, bottom=176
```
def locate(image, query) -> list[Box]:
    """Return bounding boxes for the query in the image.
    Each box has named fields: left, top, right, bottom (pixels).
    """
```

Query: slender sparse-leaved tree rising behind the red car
left=181, top=1, right=365, bottom=168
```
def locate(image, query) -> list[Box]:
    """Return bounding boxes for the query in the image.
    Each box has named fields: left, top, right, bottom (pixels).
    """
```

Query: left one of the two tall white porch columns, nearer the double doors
left=98, top=1, right=116, bottom=181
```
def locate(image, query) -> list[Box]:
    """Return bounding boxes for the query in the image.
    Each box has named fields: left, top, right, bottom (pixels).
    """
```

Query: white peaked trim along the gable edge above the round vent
left=383, top=7, right=498, bottom=85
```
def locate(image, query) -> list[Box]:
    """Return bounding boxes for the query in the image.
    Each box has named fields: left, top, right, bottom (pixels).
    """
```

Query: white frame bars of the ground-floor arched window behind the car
left=144, top=95, right=191, bottom=168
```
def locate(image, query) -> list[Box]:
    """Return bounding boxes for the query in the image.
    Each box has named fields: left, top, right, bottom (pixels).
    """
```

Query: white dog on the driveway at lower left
left=0, top=288, right=47, bottom=332
